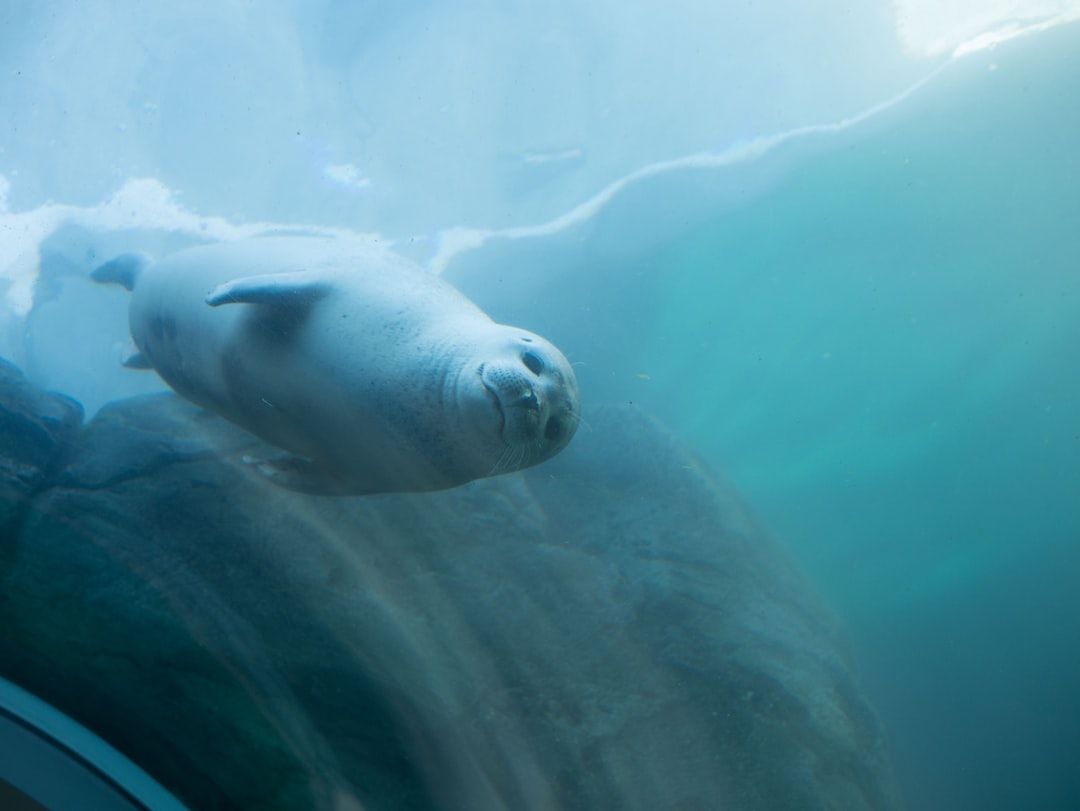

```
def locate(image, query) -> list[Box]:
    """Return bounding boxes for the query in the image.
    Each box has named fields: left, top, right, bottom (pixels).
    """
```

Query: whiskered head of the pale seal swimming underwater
left=460, top=325, right=580, bottom=473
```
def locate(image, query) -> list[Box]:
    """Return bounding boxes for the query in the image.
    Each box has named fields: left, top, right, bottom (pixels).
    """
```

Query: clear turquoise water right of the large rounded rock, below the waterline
left=640, top=31, right=1080, bottom=809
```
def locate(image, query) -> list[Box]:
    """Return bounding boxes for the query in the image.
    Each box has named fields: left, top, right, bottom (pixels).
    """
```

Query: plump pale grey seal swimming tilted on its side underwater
left=92, top=236, right=580, bottom=496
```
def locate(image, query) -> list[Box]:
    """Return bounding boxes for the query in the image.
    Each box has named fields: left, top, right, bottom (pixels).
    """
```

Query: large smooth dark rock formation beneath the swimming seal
left=0, top=360, right=900, bottom=811
